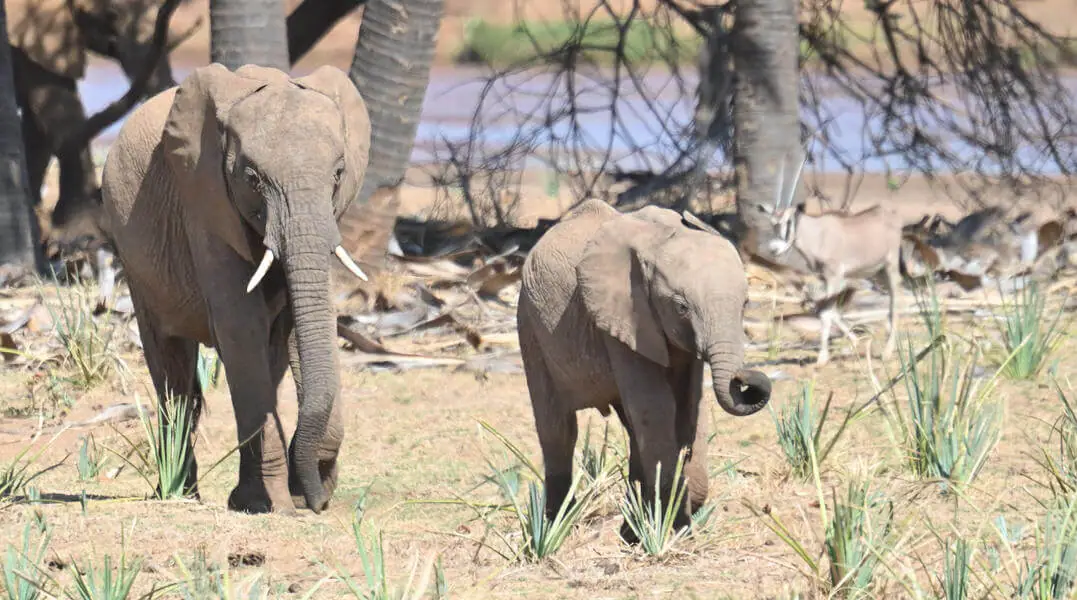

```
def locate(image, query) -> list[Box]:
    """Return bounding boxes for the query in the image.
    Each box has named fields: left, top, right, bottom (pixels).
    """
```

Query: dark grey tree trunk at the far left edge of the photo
left=0, top=2, right=38, bottom=273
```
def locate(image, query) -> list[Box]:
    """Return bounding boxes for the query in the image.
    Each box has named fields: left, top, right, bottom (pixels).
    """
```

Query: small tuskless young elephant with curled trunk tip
left=517, top=199, right=770, bottom=543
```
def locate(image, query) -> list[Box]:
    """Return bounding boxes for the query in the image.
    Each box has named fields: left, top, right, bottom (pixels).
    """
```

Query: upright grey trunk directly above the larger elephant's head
left=209, top=0, right=289, bottom=72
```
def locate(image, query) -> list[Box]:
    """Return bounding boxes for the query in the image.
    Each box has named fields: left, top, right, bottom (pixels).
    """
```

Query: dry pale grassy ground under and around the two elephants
left=6, top=183, right=1077, bottom=599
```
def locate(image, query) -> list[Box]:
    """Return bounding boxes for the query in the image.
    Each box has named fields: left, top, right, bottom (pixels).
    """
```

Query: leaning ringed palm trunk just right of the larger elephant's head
left=349, top=0, right=445, bottom=206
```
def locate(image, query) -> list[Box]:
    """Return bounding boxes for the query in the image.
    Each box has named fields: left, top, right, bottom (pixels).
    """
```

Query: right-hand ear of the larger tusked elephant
left=293, top=65, right=370, bottom=219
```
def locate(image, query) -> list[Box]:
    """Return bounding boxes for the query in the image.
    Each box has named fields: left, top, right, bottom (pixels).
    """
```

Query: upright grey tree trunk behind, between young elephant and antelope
left=731, top=0, right=802, bottom=264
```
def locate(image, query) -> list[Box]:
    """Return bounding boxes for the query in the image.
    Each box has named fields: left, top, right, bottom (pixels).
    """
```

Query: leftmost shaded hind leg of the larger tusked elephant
left=131, top=290, right=205, bottom=498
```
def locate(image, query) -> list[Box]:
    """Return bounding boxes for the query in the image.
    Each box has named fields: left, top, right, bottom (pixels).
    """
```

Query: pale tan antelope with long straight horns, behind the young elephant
left=760, top=156, right=901, bottom=365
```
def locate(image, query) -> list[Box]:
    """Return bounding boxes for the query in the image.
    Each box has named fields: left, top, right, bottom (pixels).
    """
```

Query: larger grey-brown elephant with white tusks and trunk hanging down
left=102, top=64, right=369, bottom=513
